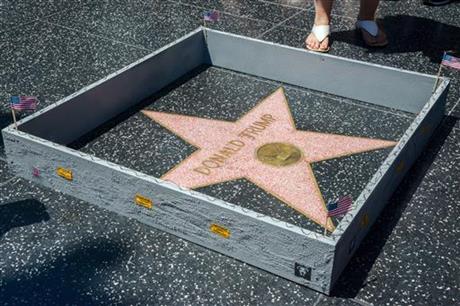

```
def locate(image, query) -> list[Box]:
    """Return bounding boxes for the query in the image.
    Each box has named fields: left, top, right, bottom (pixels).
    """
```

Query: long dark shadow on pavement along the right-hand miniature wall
left=331, top=116, right=458, bottom=298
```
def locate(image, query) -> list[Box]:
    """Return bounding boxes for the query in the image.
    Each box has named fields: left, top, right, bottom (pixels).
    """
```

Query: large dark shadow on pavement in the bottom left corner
left=0, top=239, right=129, bottom=305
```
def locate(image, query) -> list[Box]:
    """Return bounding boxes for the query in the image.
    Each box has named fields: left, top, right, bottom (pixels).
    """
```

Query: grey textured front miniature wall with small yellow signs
left=3, top=128, right=334, bottom=292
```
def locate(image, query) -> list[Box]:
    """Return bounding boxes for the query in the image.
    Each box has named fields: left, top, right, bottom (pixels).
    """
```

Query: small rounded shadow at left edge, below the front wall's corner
left=0, top=199, right=50, bottom=238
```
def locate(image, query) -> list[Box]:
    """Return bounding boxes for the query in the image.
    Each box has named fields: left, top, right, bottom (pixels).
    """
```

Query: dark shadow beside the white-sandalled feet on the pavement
left=332, top=15, right=460, bottom=63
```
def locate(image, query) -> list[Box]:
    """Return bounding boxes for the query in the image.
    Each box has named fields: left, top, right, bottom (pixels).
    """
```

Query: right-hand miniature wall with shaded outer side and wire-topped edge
left=331, top=79, right=449, bottom=286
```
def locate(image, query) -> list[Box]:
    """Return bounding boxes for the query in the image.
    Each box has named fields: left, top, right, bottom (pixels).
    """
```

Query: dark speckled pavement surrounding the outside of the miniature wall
left=0, top=0, right=460, bottom=305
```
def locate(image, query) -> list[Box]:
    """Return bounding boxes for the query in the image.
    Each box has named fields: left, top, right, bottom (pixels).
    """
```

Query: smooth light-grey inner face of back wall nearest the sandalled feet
left=207, top=30, right=435, bottom=113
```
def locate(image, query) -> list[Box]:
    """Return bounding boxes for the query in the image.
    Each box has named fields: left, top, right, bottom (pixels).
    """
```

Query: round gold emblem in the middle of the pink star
left=256, top=142, right=302, bottom=167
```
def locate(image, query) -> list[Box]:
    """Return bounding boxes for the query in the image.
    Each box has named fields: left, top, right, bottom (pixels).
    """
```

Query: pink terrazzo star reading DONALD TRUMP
left=143, top=88, right=396, bottom=231
